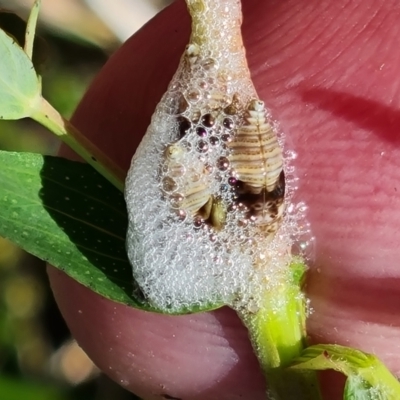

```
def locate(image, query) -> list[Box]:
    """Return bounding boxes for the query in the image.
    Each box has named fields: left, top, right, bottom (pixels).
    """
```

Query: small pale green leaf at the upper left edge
left=0, top=29, right=41, bottom=119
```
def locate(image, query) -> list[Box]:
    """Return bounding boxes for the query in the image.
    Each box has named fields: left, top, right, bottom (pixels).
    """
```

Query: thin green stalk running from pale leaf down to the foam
left=31, top=98, right=125, bottom=191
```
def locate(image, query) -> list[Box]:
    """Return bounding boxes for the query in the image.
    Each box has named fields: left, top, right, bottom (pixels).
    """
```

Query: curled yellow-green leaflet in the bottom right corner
left=290, top=344, right=400, bottom=400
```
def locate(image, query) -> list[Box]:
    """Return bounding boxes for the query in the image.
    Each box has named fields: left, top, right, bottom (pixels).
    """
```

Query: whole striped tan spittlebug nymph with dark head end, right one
left=227, top=100, right=285, bottom=233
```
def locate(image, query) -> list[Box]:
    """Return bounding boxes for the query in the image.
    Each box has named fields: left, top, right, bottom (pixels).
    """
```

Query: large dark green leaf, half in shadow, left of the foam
left=0, top=151, right=216, bottom=313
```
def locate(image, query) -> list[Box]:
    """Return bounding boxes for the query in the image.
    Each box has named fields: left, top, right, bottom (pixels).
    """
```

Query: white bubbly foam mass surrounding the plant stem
left=126, top=1, right=306, bottom=312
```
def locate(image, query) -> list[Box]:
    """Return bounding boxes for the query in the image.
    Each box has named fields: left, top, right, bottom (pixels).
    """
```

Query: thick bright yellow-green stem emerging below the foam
left=238, top=262, right=321, bottom=400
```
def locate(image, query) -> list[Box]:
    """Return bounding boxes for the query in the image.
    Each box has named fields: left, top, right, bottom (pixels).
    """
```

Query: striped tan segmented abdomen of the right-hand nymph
left=228, top=100, right=283, bottom=193
